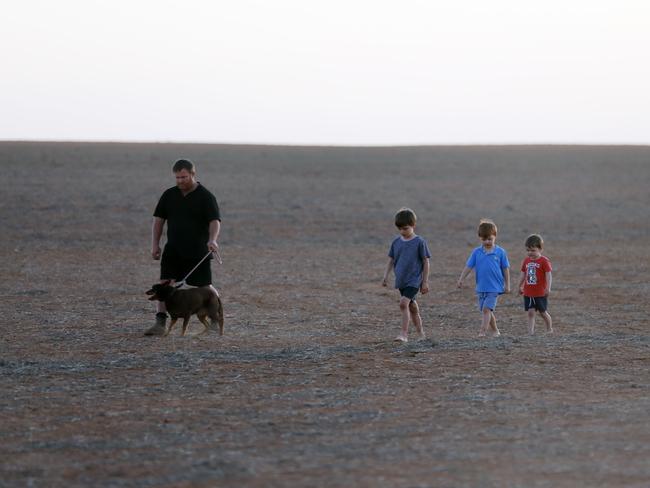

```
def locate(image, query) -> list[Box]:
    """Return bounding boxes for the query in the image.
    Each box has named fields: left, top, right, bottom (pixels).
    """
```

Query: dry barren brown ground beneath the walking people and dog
left=0, top=142, right=650, bottom=487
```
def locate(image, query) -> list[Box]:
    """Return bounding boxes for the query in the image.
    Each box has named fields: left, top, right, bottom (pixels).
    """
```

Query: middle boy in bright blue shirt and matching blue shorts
left=458, top=219, right=510, bottom=337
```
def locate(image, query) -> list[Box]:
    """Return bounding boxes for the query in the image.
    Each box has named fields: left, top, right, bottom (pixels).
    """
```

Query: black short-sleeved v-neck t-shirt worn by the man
left=153, top=183, right=221, bottom=258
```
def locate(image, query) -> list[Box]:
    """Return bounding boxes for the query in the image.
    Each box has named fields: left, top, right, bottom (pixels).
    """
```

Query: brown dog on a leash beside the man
left=147, top=281, right=223, bottom=335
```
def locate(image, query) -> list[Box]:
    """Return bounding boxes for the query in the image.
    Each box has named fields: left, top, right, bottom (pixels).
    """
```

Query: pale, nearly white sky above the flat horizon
left=0, top=0, right=650, bottom=145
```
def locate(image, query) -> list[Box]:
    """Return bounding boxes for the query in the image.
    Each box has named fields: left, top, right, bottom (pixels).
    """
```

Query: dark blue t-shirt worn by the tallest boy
left=388, top=235, right=431, bottom=288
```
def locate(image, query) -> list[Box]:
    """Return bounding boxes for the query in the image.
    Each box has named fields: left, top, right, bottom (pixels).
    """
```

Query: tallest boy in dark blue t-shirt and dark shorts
left=382, top=208, right=431, bottom=342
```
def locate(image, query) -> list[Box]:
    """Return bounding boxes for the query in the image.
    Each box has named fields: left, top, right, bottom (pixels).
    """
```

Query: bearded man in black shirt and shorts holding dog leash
left=144, top=159, right=221, bottom=335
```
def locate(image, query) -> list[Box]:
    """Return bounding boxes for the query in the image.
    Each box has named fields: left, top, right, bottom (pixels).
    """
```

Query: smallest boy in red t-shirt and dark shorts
left=519, top=234, right=553, bottom=334
